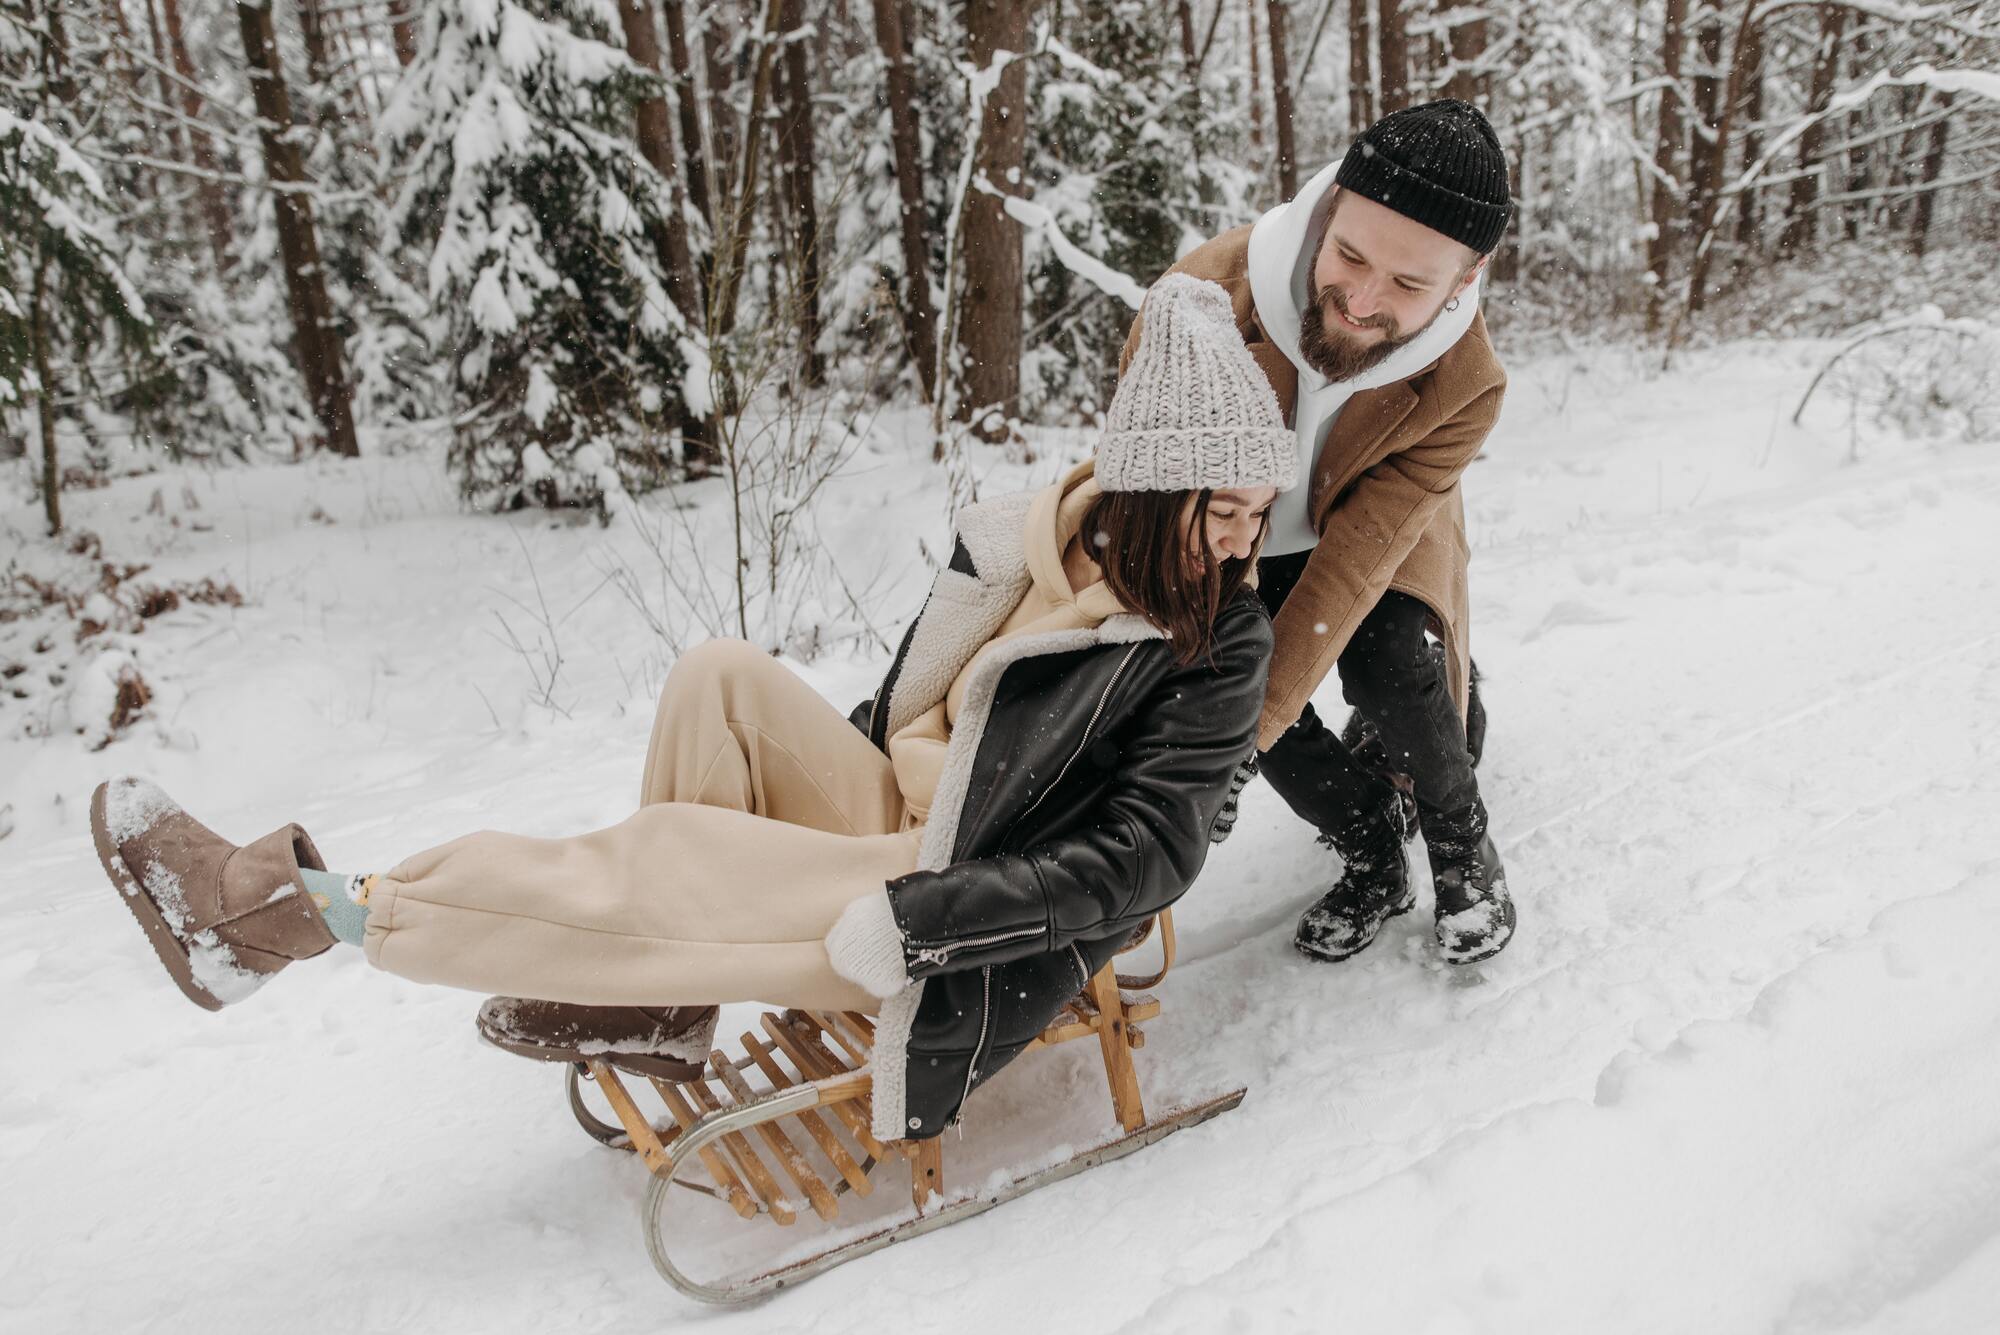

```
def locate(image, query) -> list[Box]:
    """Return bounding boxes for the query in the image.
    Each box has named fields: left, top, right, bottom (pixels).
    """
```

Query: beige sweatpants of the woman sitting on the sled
left=364, top=640, right=922, bottom=1011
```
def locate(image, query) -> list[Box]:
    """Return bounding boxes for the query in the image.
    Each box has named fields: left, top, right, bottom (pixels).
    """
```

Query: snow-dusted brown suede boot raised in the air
left=90, top=777, right=334, bottom=1011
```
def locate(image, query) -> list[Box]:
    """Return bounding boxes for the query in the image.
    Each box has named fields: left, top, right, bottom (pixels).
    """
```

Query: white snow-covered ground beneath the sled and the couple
left=0, top=344, right=2000, bottom=1335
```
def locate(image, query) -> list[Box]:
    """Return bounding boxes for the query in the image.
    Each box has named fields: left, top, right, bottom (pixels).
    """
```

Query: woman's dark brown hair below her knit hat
left=1082, top=490, right=1270, bottom=666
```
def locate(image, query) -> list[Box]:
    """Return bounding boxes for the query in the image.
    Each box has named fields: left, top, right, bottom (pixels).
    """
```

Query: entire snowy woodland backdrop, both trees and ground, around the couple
left=11, top=0, right=2000, bottom=1335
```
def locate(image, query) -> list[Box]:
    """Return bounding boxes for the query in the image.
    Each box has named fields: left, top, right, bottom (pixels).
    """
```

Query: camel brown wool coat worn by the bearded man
left=1118, top=224, right=1506, bottom=751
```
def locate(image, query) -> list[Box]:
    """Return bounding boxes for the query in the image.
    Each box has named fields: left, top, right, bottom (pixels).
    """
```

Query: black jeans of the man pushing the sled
left=1256, top=550, right=1480, bottom=833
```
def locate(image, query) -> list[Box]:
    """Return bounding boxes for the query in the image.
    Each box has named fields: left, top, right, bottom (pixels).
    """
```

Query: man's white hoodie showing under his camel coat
left=1250, top=158, right=1484, bottom=556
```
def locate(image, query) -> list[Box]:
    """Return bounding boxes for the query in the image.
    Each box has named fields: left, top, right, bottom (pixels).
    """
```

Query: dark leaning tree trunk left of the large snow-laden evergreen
left=236, top=0, right=360, bottom=456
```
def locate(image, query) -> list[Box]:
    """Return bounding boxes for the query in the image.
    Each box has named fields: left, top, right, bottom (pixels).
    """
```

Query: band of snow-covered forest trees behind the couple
left=11, top=0, right=2000, bottom=530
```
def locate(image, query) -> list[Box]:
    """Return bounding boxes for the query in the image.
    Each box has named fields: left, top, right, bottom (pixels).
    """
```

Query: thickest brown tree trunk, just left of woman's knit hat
left=958, top=0, right=1036, bottom=440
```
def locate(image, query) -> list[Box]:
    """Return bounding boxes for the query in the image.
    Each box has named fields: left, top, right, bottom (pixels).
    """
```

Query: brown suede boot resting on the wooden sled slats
left=478, top=997, right=722, bottom=1081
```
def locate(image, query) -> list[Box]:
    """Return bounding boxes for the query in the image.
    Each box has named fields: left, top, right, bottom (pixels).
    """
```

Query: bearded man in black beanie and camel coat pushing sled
left=1120, top=98, right=1514, bottom=963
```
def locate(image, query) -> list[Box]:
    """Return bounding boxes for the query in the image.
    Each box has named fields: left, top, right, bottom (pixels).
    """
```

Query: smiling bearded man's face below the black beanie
left=1298, top=190, right=1486, bottom=380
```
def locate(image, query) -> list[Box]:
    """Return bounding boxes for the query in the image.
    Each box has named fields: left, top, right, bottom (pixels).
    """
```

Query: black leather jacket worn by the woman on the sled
left=852, top=575, right=1272, bottom=1139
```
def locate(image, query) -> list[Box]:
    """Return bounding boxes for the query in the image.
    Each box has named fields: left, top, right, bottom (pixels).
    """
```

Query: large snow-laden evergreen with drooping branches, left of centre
left=382, top=0, right=708, bottom=508
